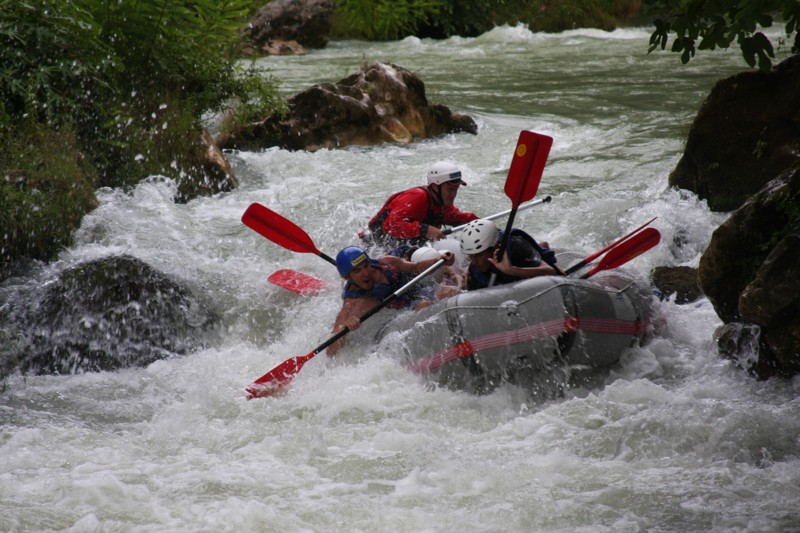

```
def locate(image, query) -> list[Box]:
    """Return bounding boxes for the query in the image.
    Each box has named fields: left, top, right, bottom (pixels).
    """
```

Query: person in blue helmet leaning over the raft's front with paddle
left=326, top=246, right=458, bottom=356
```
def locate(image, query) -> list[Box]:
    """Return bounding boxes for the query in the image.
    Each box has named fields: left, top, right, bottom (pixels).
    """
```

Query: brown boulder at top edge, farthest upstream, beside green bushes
left=244, top=0, right=334, bottom=55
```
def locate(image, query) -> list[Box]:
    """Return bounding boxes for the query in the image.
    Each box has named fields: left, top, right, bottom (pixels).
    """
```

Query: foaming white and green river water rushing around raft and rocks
left=0, top=28, right=800, bottom=532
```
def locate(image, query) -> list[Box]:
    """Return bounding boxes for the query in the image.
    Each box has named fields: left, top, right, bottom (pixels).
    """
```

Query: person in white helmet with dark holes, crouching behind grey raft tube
left=461, top=219, right=557, bottom=291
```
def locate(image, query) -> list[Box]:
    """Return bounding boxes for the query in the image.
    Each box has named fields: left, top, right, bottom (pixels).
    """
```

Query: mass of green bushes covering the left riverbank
left=0, top=0, right=285, bottom=279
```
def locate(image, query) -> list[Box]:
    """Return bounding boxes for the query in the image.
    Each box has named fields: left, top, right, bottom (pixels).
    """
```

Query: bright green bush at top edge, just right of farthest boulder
left=336, top=0, right=446, bottom=41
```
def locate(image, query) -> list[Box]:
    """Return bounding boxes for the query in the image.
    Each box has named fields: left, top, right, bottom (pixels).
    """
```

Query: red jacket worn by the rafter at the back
left=369, top=187, right=478, bottom=240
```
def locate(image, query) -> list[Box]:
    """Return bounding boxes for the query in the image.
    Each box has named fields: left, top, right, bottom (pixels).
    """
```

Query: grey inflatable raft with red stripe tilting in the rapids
left=379, top=254, right=654, bottom=396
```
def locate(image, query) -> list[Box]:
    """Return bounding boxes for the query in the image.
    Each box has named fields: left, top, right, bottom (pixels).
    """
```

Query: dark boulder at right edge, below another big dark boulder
left=698, top=163, right=800, bottom=375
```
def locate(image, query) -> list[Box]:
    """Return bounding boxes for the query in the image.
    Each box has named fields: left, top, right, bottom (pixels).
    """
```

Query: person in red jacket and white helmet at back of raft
left=361, top=161, right=478, bottom=250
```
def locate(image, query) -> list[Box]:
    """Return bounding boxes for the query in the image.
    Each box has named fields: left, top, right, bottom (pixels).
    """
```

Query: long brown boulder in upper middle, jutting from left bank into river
left=217, top=62, right=478, bottom=151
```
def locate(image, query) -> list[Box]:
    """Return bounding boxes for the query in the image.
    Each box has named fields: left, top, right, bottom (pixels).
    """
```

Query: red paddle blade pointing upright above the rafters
left=505, top=130, right=553, bottom=207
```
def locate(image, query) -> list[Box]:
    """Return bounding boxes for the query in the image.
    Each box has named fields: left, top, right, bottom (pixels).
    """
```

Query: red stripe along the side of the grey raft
left=408, top=317, right=644, bottom=374
